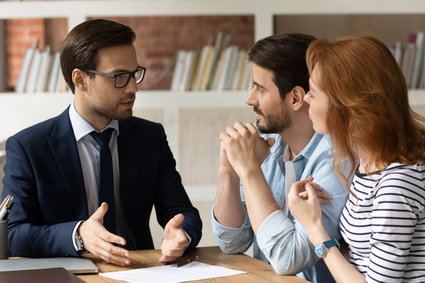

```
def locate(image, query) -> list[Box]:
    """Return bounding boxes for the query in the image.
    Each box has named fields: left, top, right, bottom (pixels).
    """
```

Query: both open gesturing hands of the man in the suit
left=78, top=202, right=189, bottom=266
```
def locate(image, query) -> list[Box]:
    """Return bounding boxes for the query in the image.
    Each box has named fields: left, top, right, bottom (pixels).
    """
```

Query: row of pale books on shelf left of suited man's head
left=15, top=40, right=67, bottom=93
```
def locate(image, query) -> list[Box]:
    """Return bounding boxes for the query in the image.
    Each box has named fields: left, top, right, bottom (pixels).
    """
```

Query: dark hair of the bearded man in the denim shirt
left=248, top=33, right=315, bottom=99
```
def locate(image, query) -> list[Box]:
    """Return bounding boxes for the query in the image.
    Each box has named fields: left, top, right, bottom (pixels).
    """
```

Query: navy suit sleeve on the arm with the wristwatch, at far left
left=2, top=137, right=78, bottom=257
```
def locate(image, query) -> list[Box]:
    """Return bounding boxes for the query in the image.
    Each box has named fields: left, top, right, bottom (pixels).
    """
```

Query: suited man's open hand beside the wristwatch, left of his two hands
left=78, top=202, right=130, bottom=266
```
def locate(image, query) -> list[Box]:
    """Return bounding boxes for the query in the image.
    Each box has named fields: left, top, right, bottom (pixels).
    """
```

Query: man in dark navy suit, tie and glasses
left=3, top=20, right=202, bottom=265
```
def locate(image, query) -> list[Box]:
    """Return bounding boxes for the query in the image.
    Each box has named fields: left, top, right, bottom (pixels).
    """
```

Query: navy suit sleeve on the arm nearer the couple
left=155, top=125, right=202, bottom=250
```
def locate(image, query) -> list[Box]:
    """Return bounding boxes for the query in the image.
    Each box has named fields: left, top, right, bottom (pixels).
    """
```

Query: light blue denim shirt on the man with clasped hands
left=211, top=133, right=348, bottom=283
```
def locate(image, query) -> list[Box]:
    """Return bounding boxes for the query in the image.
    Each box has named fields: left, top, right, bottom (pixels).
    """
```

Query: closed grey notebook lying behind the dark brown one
left=0, top=257, right=99, bottom=274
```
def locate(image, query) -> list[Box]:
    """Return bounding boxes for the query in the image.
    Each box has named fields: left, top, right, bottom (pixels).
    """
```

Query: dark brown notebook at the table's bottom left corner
left=0, top=268, right=84, bottom=283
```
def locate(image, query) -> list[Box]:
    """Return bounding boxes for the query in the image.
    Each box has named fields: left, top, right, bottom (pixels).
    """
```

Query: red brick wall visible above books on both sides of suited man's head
left=6, top=16, right=254, bottom=89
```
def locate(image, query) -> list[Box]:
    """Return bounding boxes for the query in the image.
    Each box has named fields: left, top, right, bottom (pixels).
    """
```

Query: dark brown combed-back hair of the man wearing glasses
left=60, top=19, right=136, bottom=93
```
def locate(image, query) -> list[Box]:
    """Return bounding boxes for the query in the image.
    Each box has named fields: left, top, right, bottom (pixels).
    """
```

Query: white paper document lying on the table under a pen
left=99, top=261, right=246, bottom=283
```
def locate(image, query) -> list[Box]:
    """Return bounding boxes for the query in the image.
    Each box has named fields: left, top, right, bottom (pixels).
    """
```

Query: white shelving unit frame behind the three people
left=0, top=0, right=425, bottom=160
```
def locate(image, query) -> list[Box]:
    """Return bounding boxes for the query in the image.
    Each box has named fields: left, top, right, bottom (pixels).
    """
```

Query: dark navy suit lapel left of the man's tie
left=48, top=109, right=88, bottom=220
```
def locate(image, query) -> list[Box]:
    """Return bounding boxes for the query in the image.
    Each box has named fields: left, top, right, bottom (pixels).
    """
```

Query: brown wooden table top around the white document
left=78, top=247, right=307, bottom=283
